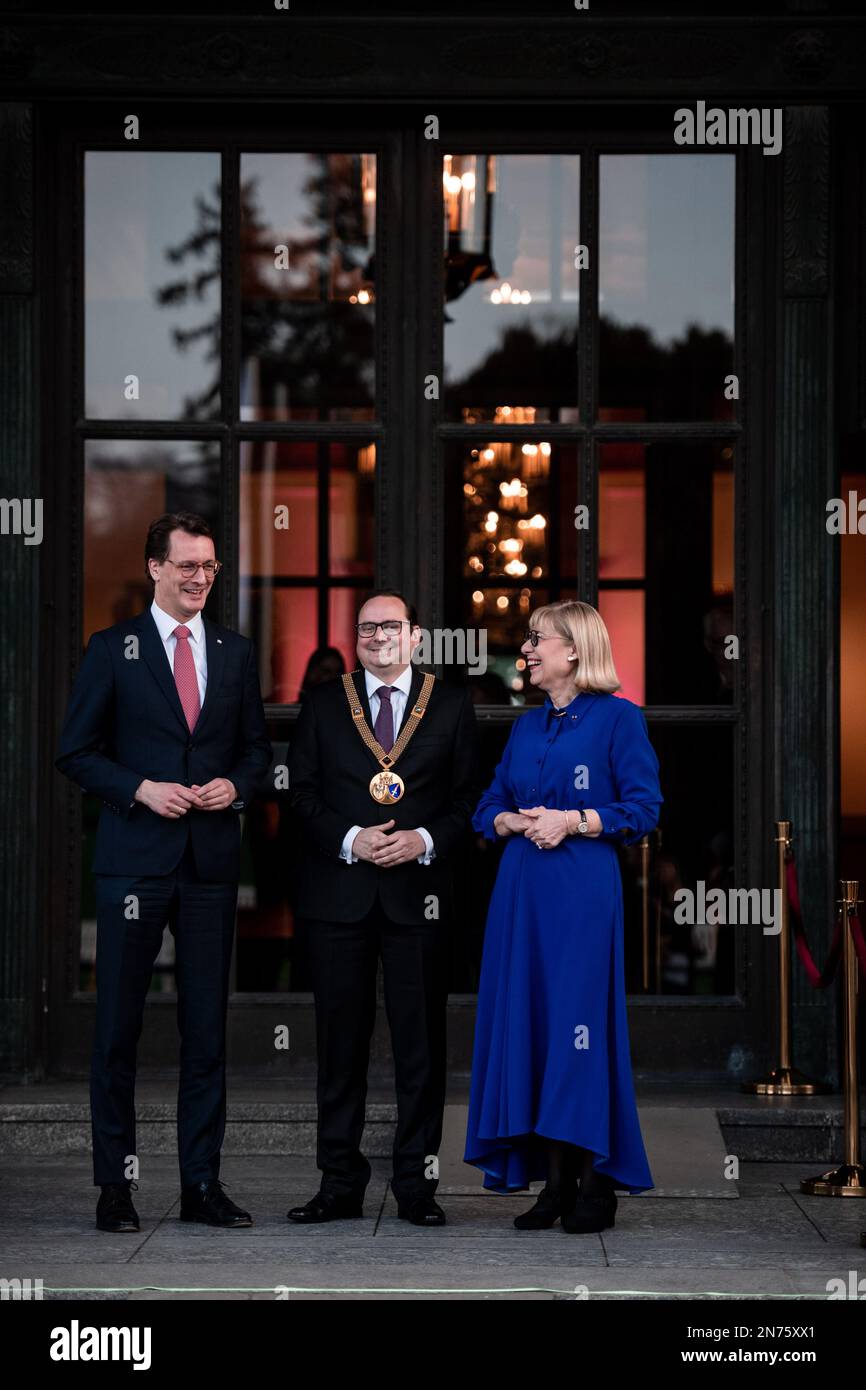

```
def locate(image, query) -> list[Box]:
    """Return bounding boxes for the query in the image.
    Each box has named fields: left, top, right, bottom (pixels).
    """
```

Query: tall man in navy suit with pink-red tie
left=57, top=513, right=271, bottom=1232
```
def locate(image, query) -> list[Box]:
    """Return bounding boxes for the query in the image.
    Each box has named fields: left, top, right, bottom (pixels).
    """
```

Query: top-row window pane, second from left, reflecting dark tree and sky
left=240, top=153, right=375, bottom=420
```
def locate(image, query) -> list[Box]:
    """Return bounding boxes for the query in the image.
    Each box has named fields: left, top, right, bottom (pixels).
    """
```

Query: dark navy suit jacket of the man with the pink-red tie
left=56, top=609, right=271, bottom=883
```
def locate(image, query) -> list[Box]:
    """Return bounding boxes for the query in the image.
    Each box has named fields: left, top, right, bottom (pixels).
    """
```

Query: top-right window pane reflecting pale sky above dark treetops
left=599, top=154, right=735, bottom=420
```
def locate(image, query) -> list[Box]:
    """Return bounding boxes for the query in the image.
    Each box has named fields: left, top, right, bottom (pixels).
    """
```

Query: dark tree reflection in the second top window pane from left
left=240, top=154, right=375, bottom=417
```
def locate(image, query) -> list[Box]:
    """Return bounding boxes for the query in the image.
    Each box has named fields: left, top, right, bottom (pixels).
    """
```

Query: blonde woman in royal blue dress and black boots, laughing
left=464, top=600, right=663, bottom=1232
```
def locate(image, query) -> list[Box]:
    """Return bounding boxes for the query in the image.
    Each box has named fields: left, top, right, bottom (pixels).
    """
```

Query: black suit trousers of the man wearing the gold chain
left=304, top=889, right=448, bottom=1201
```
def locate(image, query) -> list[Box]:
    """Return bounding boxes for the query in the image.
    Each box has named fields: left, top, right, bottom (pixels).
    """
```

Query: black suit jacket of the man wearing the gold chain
left=289, top=666, right=481, bottom=923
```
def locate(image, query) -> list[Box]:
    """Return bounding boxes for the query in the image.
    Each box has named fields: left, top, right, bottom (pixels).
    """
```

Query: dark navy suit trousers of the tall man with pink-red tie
left=90, top=838, right=238, bottom=1187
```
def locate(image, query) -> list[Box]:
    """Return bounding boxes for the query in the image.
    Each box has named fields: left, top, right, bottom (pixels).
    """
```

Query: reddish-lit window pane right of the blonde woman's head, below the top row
left=599, top=443, right=737, bottom=705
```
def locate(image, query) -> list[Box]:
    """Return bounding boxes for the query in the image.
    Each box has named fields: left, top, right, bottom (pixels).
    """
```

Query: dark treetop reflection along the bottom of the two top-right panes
left=448, top=314, right=733, bottom=420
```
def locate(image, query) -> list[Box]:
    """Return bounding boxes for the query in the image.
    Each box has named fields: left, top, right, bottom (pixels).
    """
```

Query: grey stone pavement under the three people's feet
left=0, top=1154, right=866, bottom=1295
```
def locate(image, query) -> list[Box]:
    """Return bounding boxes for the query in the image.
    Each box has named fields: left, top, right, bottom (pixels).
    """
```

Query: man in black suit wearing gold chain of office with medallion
left=288, top=589, right=480, bottom=1226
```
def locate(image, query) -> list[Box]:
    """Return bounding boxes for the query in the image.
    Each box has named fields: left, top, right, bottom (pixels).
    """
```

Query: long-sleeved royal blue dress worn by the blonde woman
left=464, top=692, right=663, bottom=1194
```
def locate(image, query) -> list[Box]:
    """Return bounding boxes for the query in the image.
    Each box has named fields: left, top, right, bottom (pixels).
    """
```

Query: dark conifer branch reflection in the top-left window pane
left=156, top=183, right=221, bottom=420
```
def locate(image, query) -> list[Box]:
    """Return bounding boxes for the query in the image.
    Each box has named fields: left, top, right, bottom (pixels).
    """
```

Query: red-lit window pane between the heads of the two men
left=239, top=439, right=375, bottom=703
